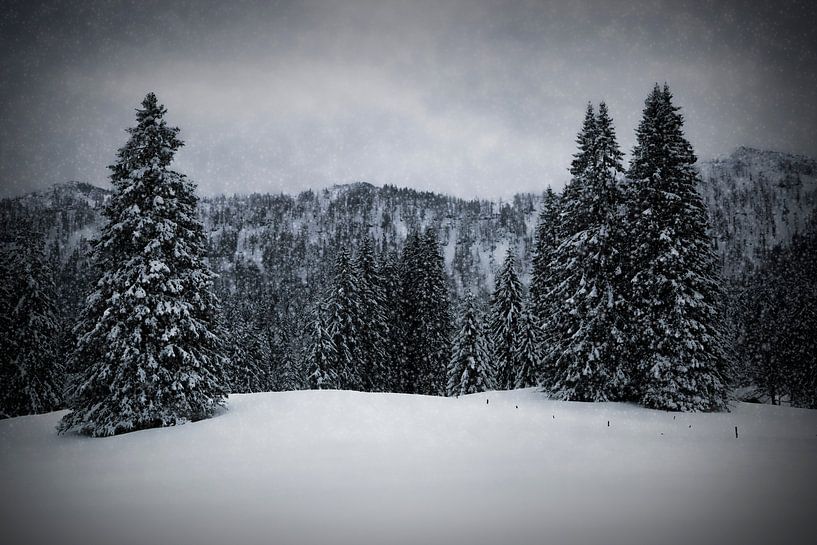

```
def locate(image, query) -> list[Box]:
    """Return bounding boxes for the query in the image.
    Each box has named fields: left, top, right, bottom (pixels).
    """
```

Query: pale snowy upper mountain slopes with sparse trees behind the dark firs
left=2, top=144, right=817, bottom=295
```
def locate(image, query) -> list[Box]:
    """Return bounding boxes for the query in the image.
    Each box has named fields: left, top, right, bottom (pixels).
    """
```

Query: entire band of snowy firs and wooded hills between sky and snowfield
left=0, top=86, right=817, bottom=435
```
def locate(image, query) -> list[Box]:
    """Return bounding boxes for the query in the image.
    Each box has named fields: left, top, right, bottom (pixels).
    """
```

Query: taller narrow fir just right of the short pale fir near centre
left=489, top=247, right=524, bottom=390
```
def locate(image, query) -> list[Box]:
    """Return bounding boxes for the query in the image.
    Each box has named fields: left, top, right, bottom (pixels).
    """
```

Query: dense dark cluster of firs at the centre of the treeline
left=307, top=229, right=451, bottom=395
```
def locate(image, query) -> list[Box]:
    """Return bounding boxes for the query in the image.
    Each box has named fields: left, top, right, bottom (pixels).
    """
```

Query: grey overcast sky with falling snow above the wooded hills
left=0, top=0, right=817, bottom=197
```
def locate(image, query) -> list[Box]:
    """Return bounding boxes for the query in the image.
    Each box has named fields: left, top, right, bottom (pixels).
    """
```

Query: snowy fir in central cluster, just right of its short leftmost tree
left=326, top=248, right=366, bottom=390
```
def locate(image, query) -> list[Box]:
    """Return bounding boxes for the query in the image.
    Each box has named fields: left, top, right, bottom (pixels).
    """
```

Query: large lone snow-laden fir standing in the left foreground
left=60, top=93, right=227, bottom=436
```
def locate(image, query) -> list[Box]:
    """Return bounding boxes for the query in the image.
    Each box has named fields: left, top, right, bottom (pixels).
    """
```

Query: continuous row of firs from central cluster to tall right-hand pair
left=296, top=86, right=732, bottom=411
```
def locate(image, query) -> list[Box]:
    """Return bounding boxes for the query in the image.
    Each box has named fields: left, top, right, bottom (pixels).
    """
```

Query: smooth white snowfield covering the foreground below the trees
left=0, top=390, right=817, bottom=545
